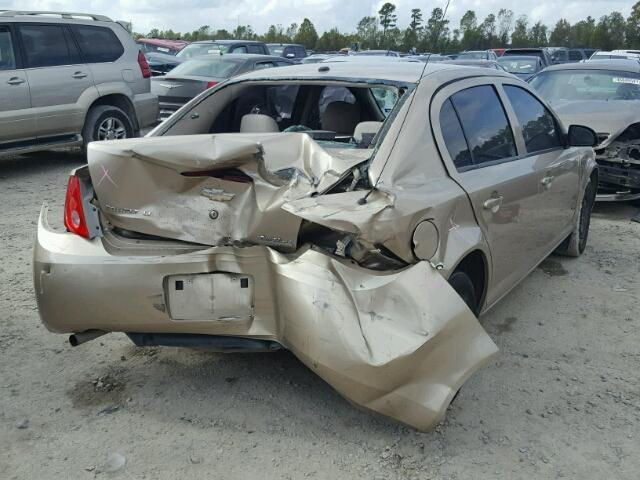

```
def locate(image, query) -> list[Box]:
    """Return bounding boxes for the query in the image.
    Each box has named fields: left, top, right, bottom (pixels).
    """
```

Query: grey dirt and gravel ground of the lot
left=0, top=152, right=640, bottom=480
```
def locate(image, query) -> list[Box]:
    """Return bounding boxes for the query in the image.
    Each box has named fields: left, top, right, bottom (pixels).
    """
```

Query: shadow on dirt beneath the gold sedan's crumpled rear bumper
left=67, top=342, right=414, bottom=435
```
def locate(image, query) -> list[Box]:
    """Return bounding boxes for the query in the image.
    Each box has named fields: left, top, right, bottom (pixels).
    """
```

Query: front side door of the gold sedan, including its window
left=502, top=82, right=580, bottom=246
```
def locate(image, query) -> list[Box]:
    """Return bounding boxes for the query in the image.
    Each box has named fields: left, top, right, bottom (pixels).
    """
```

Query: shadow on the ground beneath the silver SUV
left=0, top=148, right=86, bottom=180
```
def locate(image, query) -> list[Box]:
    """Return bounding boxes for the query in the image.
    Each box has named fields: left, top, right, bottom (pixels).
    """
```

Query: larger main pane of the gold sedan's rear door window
left=451, top=85, right=517, bottom=165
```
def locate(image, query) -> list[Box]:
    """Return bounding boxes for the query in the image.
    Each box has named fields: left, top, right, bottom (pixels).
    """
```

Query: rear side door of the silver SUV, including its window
left=17, top=23, right=95, bottom=138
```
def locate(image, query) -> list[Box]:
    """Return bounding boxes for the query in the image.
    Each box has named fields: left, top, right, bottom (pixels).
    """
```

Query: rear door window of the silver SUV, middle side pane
left=18, top=25, right=76, bottom=68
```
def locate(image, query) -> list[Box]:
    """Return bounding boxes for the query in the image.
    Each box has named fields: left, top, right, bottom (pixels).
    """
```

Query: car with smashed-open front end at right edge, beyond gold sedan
left=530, top=60, right=640, bottom=201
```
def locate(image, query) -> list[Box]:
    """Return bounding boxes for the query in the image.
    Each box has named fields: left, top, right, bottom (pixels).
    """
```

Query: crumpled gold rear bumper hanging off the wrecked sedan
left=33, top=206, right=497, bottom=429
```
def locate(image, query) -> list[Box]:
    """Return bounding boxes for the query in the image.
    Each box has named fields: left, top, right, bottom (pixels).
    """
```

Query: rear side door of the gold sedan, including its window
left=431, top=78, right=541, bottom=304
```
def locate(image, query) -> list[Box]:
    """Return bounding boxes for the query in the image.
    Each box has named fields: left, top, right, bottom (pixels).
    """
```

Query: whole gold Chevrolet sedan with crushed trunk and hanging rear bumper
left=33, top=62, right=597, bottom=429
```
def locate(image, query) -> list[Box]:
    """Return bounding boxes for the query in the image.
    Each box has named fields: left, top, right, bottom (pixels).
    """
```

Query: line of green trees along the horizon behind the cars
left=142, top=1, right=640, bottom=53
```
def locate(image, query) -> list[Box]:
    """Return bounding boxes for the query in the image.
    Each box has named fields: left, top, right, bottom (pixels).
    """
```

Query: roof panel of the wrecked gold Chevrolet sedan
left=228, top=60, right=512, bottom=83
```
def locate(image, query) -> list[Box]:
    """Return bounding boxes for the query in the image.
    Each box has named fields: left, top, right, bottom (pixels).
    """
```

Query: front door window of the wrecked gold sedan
left=504, top=85, right=562, bottom=153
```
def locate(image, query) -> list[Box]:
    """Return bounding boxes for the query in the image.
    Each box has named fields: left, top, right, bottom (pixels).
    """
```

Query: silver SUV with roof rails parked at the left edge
left=0, top=10, right=158, bottom=154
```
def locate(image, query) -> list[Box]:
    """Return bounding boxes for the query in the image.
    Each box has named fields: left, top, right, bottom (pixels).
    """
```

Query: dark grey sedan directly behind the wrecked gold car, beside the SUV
left=151, top=54, right=293, bottom=120
